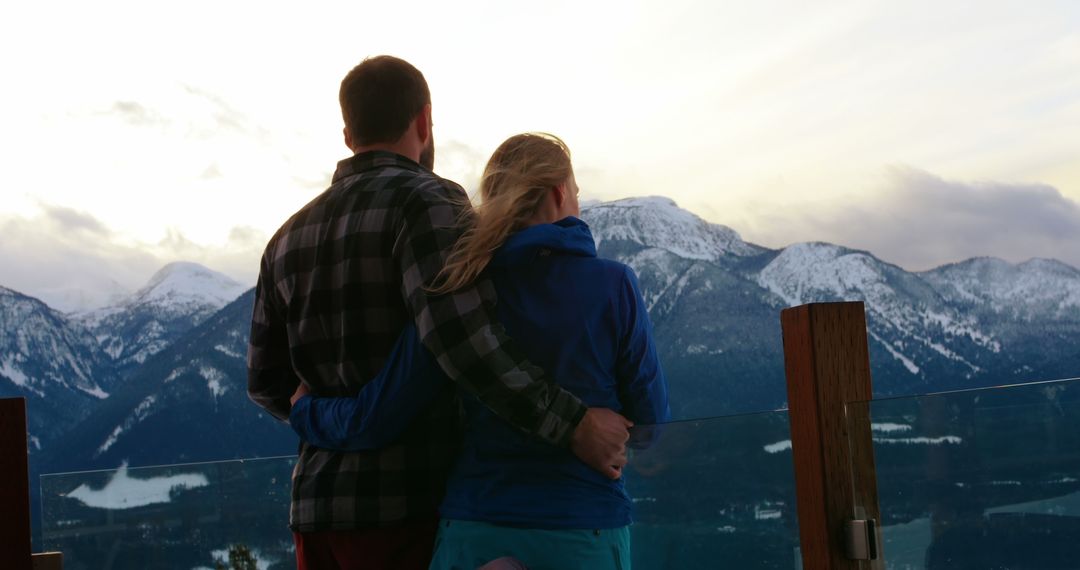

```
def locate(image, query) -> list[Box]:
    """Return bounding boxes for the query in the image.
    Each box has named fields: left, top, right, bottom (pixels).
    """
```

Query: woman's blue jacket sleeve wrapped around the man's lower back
left=288, top=323, right=449, bottom=451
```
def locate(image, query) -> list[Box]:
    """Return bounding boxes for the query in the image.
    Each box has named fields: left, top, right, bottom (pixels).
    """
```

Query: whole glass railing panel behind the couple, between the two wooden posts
left=41, top=411, right=798, bottom=570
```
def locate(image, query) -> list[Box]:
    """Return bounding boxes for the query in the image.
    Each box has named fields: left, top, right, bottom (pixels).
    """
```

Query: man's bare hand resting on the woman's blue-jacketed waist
left=570, top=408, right=634, bottom=479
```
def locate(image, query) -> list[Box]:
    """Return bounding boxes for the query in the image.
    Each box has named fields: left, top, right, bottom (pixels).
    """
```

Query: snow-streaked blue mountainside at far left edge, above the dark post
left=0, top=287, right=118, bottom=450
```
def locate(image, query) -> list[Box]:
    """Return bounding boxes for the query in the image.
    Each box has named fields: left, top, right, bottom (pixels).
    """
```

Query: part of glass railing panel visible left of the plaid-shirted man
left=41, top=458, right=296, bottom=570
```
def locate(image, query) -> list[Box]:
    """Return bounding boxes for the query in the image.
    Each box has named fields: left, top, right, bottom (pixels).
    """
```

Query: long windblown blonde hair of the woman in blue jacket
left=432, top=133, right=573, bottom=294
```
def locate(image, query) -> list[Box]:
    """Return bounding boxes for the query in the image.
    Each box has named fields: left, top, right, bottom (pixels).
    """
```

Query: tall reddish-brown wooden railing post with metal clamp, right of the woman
left=780, top=302, right=882, bottom=570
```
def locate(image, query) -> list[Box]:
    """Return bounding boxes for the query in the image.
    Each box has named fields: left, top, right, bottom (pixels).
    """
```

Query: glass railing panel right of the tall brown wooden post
left=848, top=379, right=1080, bottom=570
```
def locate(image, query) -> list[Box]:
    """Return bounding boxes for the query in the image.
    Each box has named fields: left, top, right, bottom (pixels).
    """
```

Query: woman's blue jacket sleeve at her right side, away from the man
left=617, top=267, right=671, bottom=448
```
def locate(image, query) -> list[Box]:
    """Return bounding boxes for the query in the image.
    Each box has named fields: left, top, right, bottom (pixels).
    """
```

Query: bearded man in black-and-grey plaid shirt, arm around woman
left=247, top=56, right=629, bottom=569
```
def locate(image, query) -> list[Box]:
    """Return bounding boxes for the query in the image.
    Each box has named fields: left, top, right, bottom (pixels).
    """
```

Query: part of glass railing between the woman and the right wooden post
left=625, top=410, right=798, bottom=569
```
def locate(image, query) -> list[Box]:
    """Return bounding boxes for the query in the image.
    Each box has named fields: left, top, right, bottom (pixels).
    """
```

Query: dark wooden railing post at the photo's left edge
left=0, top=398, right=30, bottom=570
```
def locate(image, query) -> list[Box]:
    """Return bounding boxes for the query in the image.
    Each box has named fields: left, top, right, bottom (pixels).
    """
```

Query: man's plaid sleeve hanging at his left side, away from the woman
left=247, top=254, right=300, bottom=420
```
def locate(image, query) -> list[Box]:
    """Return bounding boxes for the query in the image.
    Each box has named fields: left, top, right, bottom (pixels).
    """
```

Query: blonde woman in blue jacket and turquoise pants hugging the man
left=291, top=134, right=669, bottom=570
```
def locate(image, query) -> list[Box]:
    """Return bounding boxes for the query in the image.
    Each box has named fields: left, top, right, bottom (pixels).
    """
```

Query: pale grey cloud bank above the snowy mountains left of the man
left=0, top=204, right=261, bottom=311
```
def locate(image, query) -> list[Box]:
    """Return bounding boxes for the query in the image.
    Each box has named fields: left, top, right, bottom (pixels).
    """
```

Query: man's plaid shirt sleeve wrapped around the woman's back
left=394, top=180, right=586, bottom=446
